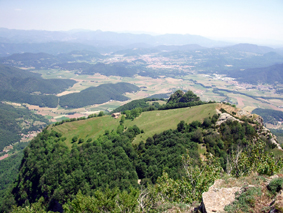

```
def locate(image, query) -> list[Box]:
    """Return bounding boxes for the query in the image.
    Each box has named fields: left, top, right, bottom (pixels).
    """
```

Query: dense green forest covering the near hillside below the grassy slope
left=1, top=97, right=282, bottom=212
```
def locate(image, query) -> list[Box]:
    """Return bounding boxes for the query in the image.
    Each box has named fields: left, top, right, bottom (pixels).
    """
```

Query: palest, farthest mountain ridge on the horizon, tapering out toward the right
left=0, top=28, right=231, bottom=47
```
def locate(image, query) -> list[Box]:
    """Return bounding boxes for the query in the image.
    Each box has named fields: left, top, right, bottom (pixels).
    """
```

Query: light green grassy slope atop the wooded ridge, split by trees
left=52, top=104, right=217, bottom=147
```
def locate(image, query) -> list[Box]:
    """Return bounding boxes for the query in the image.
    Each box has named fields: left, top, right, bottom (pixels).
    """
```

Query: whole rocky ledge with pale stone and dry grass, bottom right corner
left=201, top=174, right=283, bottom=213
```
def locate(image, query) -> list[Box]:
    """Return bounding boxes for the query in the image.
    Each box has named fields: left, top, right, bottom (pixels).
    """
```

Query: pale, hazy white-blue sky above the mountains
left=0, top=0, right=283, bottom=44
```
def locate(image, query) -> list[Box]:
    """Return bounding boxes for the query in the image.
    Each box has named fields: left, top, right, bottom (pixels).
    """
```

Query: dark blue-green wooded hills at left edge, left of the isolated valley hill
left=0, top=65, right=75, bottom=107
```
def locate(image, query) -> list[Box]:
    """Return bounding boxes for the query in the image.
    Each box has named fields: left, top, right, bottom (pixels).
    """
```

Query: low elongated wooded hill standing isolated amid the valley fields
left=59, top=83, right=139, bottom=108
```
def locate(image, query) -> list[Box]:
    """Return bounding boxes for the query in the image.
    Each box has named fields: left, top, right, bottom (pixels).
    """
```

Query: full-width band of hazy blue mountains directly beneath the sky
left=0, top=28, right=283, bottom=57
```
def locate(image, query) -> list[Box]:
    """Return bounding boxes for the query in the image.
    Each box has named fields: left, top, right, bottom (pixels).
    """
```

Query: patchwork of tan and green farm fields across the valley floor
left=31, top=60, right=283, bottom=125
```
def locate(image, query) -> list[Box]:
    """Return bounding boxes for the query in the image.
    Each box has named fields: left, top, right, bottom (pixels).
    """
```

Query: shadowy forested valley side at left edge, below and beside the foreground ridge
left=0, top=103, right=49, bottom=206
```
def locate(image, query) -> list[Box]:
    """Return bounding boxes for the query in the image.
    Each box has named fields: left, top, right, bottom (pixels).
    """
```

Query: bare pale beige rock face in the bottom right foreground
left=201, top=180, right=241, bottom=213
